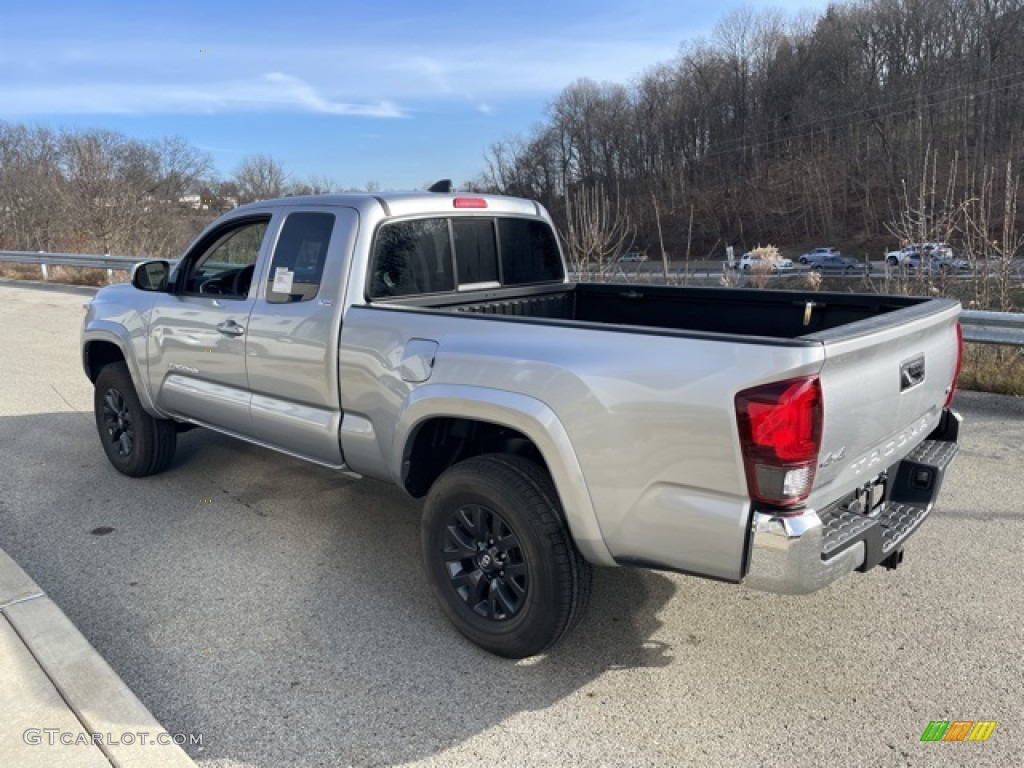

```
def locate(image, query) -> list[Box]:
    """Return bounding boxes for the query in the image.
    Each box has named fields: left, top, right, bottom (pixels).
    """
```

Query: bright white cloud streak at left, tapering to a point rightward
left=0, top=72, right=406, bottom=118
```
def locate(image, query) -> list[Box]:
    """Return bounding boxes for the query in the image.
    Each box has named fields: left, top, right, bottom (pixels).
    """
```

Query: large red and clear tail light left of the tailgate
left=736, top=376, right=824, bottom=507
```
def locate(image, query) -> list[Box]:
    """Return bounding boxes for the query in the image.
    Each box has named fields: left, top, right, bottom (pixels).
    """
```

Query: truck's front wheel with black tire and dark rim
left=92, top=362, right=178, bottom=477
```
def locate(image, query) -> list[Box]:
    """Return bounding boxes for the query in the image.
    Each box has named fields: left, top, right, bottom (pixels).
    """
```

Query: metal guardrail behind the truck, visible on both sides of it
left=0, top=251, right=1024, bottom=347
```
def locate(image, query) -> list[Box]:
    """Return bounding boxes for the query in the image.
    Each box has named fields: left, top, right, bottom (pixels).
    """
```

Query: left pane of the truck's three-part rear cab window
left=370, top=219, right=455, bottom=299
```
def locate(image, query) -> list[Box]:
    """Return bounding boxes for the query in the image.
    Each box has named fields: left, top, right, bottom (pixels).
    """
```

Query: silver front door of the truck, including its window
left=148, top=214, right=270, bottom=436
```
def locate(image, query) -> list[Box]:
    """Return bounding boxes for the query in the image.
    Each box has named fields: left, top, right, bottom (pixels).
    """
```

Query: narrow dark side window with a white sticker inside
left=266, top=213, right=334, bottom=304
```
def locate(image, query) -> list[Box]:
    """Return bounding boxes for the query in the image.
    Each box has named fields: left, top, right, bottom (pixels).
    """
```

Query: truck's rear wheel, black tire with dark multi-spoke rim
left=421, top=454, right=591, bottom=658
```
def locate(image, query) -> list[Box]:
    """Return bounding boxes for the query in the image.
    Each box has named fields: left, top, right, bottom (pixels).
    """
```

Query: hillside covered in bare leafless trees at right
left=480, top=0, right=1024, bottom=258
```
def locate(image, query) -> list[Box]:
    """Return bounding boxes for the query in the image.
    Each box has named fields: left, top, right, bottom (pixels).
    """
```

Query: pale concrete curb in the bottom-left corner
left=0, top=550, right=196, bottom=768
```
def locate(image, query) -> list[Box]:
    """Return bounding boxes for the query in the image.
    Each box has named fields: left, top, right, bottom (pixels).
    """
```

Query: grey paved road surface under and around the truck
left=0, top=284, right=1024, bottom=768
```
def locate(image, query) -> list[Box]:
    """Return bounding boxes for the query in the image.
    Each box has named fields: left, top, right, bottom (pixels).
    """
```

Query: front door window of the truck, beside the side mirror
left=182, top=218, right=269, bottom=299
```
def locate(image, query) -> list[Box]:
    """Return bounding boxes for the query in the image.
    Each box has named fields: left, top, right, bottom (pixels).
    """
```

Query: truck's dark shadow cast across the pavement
left=0, top=414, right=685, bottom=765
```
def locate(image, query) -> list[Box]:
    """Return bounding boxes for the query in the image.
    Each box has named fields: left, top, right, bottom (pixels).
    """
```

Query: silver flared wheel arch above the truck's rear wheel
left=393, top=385, right=615, bottom=565
